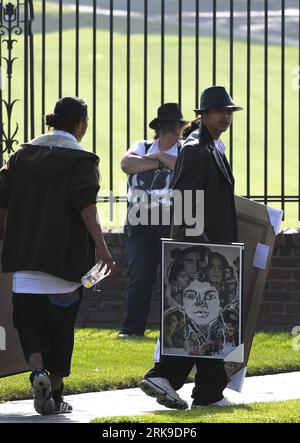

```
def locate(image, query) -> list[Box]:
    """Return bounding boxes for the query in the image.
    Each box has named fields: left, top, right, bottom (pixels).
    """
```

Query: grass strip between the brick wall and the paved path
left=0, top=329, right=300, bottom=401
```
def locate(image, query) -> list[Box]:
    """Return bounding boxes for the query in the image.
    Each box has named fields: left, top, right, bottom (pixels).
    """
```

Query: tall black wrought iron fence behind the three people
left=0, top=0, right=300, bottom=220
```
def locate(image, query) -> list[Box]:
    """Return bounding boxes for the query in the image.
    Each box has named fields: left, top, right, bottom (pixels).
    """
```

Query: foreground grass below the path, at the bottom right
left=93, top=400, right=300, bottom=423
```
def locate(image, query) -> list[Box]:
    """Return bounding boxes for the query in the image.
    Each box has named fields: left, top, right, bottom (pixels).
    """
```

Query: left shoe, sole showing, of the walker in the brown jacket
left=29, top=369, right=55, bottom=415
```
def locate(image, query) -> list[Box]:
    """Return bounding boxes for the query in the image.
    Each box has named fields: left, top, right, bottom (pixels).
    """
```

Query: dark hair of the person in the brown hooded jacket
left=45, top=97, right=88, bottom=133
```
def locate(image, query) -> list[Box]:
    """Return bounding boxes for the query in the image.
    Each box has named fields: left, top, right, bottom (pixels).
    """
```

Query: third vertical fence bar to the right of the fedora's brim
left=281, top=0, right=285, bottom=214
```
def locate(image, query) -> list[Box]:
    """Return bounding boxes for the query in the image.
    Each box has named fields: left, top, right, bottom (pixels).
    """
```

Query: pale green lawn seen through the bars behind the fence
left=2, top=0, right=299, bottom=226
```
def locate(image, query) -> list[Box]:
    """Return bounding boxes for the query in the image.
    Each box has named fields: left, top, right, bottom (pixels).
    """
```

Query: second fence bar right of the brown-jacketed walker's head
left=109, top=0, right=114, bottom=193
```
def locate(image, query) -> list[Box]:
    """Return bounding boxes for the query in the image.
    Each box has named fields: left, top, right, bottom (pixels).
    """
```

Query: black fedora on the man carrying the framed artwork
left=194, top=86, right=243, bottom=114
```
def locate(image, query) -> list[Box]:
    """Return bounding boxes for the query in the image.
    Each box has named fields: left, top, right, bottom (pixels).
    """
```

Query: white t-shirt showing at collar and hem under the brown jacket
left=12, top=130, right=81, bottom=294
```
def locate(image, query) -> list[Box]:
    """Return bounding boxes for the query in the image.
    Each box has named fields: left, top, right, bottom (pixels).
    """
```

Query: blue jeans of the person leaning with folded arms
left=121, top=226, right=170, bottom=335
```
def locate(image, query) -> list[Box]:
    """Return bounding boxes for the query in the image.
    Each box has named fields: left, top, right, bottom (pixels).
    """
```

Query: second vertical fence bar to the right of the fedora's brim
left=264, top=0, right=268, bottom=205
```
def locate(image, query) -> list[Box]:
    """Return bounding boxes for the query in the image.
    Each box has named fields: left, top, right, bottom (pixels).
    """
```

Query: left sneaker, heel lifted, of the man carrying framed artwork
left=140, top=377, right=188, bottom=409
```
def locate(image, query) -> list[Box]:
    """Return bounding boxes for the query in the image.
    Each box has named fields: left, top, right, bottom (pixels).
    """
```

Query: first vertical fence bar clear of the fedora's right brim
left=246, top=0, right=251, bottom=198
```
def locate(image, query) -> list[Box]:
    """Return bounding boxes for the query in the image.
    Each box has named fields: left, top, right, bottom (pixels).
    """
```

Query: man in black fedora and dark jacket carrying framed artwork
left=140, top=86, right=242, bottom=409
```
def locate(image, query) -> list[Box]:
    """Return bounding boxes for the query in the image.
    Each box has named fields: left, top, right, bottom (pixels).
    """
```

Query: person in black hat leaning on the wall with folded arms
left=119, top=103, right=186, bottom=338
